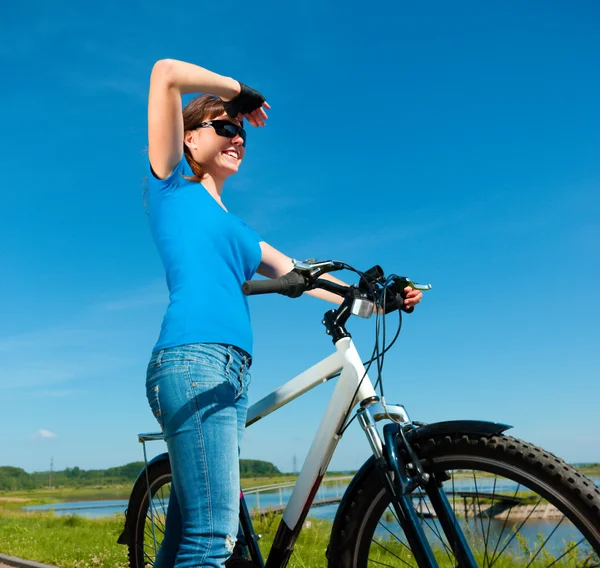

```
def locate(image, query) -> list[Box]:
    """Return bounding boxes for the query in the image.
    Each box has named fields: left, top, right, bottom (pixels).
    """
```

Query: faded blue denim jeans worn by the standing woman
left=146, top=343, right=251, bottom=568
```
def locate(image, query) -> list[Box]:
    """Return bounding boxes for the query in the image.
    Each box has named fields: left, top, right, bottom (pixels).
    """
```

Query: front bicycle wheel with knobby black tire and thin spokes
left=328, top=435, right=600, bottom=568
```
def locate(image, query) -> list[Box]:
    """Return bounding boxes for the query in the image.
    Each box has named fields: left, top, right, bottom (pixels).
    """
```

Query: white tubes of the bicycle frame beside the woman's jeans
left=246, top=337, right=408, bottom=530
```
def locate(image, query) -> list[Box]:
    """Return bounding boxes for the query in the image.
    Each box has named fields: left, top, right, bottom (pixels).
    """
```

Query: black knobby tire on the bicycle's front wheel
left=327, top=434, right=600, bottom=568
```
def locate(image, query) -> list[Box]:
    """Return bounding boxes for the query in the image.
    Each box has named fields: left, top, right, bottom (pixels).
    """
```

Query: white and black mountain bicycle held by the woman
left=119, top=259, right=600, bottom=568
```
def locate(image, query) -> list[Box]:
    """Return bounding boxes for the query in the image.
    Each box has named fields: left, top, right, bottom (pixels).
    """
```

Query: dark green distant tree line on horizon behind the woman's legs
left=0, top=460, right=282, bottom=491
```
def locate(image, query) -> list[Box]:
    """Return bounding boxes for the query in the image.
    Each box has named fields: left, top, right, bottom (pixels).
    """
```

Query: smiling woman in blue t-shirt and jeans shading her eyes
left=146, top=60, right=421, bottom=568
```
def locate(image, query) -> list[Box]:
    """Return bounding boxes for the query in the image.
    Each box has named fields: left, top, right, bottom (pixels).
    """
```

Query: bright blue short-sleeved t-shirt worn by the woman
left=148, top=156, right=261, bottom=354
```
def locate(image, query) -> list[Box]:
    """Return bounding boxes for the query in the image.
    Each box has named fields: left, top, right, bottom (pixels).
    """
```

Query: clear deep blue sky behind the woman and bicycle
left=0, top=0, right=600, bottom=471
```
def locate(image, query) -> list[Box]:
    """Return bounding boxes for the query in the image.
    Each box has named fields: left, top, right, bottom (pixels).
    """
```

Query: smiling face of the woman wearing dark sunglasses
left=184, top=114, right=245, bottom=179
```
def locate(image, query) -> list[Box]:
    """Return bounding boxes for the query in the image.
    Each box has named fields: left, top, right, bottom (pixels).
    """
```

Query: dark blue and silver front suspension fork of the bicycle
left=358, top=404, right=477, bottom=568
